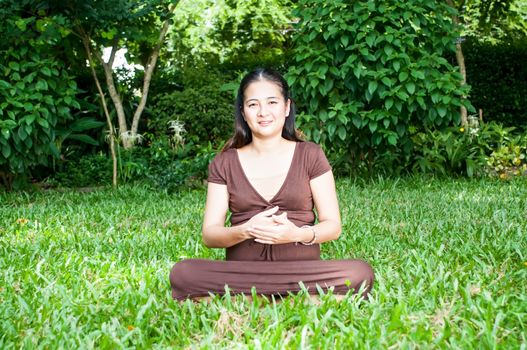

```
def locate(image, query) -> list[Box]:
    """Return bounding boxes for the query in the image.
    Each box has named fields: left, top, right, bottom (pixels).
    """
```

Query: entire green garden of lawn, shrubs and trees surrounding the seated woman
left=0, top=0, right=527, bottom=348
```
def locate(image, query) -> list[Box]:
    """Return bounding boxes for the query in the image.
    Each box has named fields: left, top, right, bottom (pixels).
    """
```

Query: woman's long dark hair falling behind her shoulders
left=223, top=68, right=304, bottom=151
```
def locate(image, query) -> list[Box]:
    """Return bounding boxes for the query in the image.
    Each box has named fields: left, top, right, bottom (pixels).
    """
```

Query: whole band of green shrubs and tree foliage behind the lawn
left=0, top=0, right=527, bottom=190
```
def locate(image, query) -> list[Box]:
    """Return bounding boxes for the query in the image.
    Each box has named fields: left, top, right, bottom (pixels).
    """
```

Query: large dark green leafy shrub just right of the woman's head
left=288, top=0, right=470, bottom=175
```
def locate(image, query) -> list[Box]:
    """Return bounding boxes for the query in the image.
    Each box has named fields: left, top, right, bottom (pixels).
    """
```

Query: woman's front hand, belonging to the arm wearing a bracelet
left=248, top=211, right=305, bottom=244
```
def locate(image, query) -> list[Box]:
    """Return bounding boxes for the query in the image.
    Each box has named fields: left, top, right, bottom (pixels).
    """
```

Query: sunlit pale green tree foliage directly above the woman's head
left=169, top=0, right=293, bottom=69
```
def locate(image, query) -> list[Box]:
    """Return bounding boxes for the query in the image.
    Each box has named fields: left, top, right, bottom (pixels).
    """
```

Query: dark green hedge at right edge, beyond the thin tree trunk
left=463, top=39, right=527, bottom=128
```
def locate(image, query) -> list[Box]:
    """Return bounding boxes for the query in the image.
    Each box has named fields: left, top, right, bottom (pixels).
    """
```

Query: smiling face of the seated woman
left=242, top=80, right=291, bottom=137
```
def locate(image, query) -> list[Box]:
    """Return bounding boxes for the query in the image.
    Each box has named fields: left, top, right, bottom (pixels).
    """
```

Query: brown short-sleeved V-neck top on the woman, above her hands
left=208, top=142, right=331, bottom=226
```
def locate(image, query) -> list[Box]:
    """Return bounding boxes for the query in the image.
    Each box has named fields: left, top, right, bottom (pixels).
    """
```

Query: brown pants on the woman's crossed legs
left=170, top=259, right=374, bottom=300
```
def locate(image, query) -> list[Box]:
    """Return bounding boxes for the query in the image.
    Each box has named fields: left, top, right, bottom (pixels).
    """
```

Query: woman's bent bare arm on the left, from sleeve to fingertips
left=202, top=182, right=278, bottom=248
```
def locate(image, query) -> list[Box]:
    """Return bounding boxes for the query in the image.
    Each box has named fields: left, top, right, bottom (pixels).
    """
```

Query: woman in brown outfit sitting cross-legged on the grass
left=170, top=69, right=373, bottom=300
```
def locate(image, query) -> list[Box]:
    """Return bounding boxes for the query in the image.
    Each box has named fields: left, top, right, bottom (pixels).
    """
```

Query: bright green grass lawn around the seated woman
left=0, top=177, right=527, bottom=349
